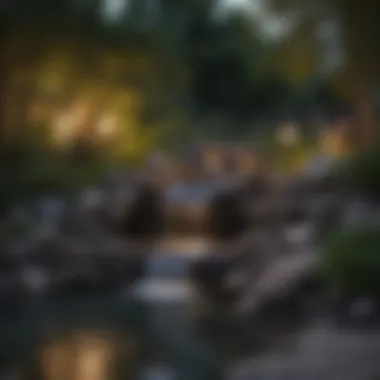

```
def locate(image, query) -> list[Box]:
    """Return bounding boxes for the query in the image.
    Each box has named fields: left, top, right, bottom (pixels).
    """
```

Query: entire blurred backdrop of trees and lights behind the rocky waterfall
left=0, top=0, right=380, bottom=196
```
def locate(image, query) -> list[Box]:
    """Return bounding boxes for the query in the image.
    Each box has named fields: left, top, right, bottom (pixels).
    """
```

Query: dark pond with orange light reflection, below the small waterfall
left=0, top=251, right=256, bottom=380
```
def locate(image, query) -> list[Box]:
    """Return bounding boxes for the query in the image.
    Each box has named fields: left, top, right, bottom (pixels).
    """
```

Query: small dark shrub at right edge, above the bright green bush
left=335, top=142, right=380, bottom=198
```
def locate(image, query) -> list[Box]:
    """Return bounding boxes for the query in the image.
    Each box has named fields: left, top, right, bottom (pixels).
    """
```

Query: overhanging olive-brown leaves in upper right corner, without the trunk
left=265, top=0, right=380, bottom=101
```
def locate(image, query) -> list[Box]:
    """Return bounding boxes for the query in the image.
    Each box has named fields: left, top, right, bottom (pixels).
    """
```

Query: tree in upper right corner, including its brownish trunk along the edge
left=267, top=0, right=380, bottom=146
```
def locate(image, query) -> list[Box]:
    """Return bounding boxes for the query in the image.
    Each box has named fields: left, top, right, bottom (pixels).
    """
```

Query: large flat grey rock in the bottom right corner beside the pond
left=229, top=327, right=380, bottom=380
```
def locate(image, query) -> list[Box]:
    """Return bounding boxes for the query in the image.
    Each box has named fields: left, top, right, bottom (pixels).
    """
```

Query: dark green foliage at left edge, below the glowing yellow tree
left=0, top=142, right=107, bottom=211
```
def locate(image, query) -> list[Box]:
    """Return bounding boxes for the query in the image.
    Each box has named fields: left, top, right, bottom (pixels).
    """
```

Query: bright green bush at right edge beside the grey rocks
left=322, top=225, right=380, bottom=297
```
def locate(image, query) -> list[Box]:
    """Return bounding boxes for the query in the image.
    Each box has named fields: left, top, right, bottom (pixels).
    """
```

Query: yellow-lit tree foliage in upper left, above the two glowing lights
left=0, top=0, right=184, bottom=153
